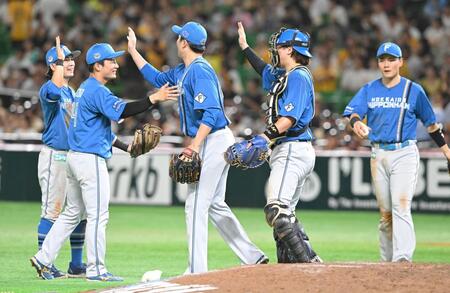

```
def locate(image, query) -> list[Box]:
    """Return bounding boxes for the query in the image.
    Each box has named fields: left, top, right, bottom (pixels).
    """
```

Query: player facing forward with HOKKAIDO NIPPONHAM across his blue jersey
left=344, top=42, right=450, bottom=262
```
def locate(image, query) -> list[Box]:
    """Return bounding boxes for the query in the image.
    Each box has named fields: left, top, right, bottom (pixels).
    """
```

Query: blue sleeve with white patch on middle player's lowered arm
left=189, top=64, right=221, bottom=110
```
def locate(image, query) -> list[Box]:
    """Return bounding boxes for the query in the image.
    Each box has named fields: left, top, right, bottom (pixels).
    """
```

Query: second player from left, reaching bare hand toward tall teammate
left=31, top=43, right=179, bottom=281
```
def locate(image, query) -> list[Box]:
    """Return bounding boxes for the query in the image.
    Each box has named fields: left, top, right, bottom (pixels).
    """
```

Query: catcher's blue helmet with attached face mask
left=269, top=27, right=312, bottom=68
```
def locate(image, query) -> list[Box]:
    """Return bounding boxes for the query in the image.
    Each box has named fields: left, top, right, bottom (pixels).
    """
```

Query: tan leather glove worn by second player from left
left=130, top=123, right=162, bottom=158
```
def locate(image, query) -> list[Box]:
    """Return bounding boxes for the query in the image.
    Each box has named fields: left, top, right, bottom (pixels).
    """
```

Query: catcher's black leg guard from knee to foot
left=264, top=202, right=311, bottom=262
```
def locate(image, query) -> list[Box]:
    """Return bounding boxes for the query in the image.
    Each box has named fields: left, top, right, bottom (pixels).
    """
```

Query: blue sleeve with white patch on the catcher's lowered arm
left=278, top=71, right=311, bottom=121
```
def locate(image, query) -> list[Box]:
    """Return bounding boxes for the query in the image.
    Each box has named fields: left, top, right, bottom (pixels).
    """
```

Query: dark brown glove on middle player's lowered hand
left=169, top=148, right=202, bottom=184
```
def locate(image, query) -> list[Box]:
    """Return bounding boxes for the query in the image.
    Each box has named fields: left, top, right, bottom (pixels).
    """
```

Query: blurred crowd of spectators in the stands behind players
left=0, top=0, right=450, bottom=149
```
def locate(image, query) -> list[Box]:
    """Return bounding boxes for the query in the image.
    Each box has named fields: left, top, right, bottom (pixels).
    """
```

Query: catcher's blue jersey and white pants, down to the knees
left=262, top=64, right=316, bottom=213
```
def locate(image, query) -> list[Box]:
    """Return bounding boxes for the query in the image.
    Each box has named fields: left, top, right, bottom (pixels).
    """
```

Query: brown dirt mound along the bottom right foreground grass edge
left=100, top=263, right=450, bottom=293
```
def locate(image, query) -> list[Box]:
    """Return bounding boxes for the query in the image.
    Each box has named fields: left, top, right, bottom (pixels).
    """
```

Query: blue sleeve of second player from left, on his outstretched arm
left=90, top=87, right=126, bottom=121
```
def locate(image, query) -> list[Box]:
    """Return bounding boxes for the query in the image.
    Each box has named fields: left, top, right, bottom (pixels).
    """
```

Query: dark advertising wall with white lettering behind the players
left=0, top=150, right=450, bottom=213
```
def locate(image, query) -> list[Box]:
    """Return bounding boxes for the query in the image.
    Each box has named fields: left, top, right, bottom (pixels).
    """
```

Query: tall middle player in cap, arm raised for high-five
left=128, top=22, right=268, bottom=273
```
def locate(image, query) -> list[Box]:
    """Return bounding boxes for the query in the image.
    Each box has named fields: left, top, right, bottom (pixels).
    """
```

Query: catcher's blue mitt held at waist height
left=224, top=135, right=269, bottom=170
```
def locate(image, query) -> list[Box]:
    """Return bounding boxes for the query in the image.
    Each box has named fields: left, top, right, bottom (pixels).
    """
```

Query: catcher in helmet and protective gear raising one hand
left=238, top=22, right=322, bottom=263
